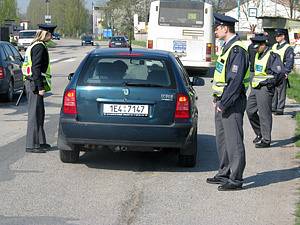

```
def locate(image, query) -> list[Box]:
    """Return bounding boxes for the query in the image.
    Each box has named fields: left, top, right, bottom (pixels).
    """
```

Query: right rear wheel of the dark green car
left=178, top=128, right=198, bottom=167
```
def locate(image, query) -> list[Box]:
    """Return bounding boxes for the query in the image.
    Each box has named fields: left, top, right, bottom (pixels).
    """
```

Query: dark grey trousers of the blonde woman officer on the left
left=25, top=80, right=46, bottom=148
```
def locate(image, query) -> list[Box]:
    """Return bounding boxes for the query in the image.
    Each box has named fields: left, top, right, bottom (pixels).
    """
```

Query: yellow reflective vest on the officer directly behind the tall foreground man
left=252, top=50, right=274, bottom=88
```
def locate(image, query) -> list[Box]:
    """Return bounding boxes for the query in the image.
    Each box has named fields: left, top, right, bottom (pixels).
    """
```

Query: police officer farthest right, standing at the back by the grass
left=272, top=29, right=294, bottom=115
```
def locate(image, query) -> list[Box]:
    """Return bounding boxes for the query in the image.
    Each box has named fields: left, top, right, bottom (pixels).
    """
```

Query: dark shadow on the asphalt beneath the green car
left=80, top=134, right=218, bottom=172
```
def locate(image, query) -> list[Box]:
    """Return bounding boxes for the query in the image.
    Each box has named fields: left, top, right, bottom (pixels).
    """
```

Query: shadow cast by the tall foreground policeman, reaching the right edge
left=244, top=167, right=300, bottom=189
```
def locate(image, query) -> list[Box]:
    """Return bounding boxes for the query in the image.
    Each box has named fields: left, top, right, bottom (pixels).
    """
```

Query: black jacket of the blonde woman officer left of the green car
left=31, top=44, right=49, bottom=90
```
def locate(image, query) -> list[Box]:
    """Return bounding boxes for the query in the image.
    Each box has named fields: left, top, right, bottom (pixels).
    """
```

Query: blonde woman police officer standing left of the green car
left=22, top=24, right=56, bottom=153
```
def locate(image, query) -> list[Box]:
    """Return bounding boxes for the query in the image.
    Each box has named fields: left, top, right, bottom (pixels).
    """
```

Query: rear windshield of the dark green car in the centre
left=78, top=56, right=175, bottom=88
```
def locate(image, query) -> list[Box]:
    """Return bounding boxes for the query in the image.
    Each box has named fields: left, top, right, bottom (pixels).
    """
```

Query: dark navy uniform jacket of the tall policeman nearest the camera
left=217, top=35, right=249, bottom=111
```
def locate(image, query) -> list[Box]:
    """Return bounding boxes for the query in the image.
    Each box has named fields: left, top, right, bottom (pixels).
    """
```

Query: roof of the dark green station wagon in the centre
left=90, top=48, right=171, bottom=57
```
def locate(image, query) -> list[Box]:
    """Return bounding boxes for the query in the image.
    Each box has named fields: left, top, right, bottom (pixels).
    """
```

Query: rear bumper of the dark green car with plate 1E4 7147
left=57, top=118, right=197, bottom=150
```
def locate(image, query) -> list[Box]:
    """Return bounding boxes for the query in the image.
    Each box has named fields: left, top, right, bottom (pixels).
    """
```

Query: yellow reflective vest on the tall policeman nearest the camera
left=212, top=41, right=250, bottom=97
